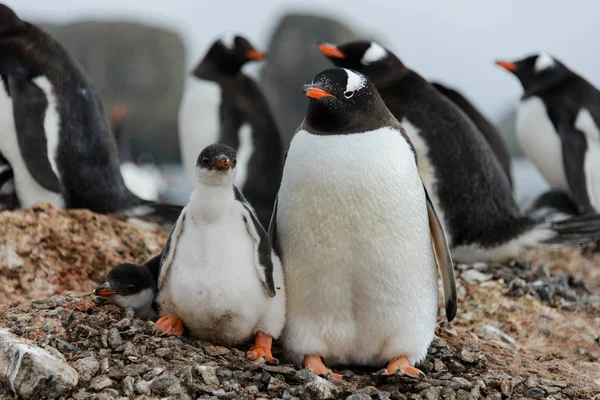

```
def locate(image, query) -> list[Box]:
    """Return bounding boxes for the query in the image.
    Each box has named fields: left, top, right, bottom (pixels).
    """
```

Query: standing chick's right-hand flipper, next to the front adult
left=233, top=186, right=277, bottom=297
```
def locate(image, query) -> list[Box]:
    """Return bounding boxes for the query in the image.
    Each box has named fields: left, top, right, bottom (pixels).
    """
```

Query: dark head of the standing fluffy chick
left=196, top=143, right=237, bottom=185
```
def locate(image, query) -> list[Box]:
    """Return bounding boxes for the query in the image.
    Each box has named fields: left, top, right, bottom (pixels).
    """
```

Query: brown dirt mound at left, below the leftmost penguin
left=0, top=204, right=168, bottom=304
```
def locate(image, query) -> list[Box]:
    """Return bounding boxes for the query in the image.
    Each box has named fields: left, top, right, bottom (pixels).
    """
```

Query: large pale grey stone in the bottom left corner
left=0, top=329, right=78, bottom=399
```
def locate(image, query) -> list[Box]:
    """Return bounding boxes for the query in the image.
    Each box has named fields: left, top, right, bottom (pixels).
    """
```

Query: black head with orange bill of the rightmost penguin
left=496, top=53, right=572, bottom=93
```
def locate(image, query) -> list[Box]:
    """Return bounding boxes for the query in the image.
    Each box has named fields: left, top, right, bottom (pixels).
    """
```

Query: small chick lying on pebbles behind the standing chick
left=94, top=254, right=162, bottom=320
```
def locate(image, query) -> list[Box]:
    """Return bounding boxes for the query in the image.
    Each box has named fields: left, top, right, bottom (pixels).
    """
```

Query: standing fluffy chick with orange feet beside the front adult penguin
left=156, top=144, right=285, bottom=361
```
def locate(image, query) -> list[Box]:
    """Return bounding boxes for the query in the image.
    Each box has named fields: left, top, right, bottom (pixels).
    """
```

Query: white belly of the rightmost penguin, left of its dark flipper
left=517, top=97, right=569, bottom=191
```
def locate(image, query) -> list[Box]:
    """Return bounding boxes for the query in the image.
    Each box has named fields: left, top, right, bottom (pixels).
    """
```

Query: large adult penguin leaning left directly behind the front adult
left=319, top=41, right=600, bottom=262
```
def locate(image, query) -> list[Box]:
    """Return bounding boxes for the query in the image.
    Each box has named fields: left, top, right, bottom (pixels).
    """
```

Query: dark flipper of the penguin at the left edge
left=8, top=77, right=62, bottom=193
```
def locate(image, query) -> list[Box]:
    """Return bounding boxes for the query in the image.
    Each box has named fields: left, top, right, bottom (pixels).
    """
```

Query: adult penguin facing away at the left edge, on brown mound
left=0, top=5, right=181, bottom=223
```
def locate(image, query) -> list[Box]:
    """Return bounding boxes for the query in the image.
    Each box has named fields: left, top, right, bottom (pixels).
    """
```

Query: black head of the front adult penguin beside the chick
left=302, top=68, right=389, bottom=134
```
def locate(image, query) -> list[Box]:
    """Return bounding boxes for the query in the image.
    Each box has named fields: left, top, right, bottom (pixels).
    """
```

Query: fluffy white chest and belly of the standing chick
left=159, top=186, right=285, bottom=345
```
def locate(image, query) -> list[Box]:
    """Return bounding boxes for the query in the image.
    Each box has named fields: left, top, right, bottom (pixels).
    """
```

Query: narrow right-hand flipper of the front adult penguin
left=423, top=187, right=458, bottom=322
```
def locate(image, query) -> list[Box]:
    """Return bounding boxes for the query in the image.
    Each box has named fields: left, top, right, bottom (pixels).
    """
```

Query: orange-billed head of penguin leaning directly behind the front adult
left=317, top=40, right=406, bottom=88
